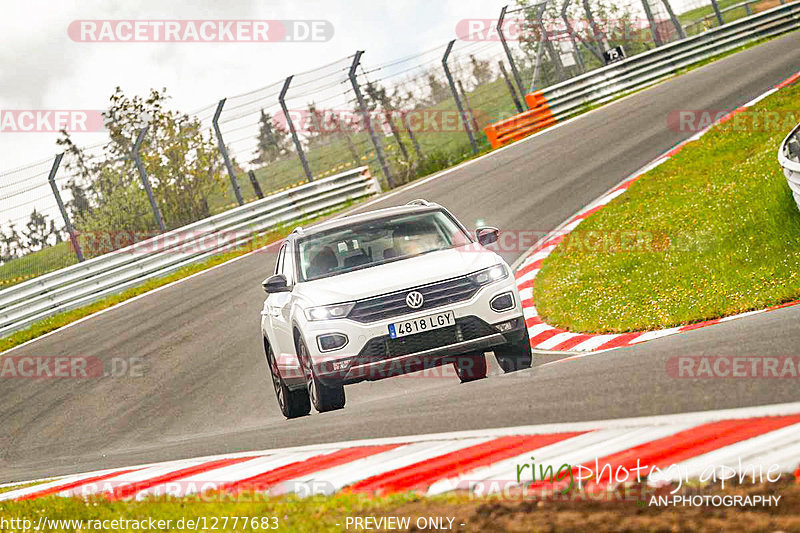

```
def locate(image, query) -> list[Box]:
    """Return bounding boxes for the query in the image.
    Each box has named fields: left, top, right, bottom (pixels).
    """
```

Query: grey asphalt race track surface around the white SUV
left=0, top=32, right=800, bottom=481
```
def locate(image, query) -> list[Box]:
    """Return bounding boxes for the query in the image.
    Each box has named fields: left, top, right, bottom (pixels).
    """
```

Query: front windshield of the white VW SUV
left=297, top=210, right=471, bottom=281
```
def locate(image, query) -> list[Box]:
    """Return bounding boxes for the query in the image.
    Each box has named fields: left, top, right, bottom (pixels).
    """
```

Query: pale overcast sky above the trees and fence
left=0, top=0, right=514, bottom=175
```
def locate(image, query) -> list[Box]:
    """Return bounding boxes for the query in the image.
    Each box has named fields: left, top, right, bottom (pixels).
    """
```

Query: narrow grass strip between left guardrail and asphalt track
left=0, top=202, right=356, bottom=356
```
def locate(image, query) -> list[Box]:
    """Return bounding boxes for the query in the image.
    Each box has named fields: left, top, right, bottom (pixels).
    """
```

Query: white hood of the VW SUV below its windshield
left=295, top=245, right=502, bottom=305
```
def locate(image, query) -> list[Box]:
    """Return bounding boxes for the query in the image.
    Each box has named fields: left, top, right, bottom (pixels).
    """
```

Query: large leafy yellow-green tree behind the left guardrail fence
left=58, top=87, right=222, bottom=237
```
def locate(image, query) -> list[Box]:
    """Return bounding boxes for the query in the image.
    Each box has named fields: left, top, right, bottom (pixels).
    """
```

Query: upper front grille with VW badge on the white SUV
left=347, top=276, right=480, bottom=322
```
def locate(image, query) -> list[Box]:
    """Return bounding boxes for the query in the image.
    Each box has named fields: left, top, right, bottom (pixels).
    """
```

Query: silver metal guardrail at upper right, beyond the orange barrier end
left=536, top=2, right=800, bottom=120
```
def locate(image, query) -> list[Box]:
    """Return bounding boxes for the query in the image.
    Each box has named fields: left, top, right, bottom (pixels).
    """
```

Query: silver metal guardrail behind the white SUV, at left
left=0, top=167, right=381, bottom=337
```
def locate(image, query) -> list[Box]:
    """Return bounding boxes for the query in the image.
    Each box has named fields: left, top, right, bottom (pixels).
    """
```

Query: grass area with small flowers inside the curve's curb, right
left=533, top=79, right=800, bottom=333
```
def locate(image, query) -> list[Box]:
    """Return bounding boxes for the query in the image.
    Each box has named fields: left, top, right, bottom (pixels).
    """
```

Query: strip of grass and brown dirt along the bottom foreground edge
left=0, top=475, right=800, bottom=533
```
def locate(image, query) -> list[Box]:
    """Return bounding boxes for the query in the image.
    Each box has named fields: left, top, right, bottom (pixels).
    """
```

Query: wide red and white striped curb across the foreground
left=0, top=403, right=800, bottom=501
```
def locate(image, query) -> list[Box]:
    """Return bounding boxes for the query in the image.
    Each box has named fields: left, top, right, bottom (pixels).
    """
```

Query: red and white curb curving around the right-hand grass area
left=515, top=72, right=800, bottom=354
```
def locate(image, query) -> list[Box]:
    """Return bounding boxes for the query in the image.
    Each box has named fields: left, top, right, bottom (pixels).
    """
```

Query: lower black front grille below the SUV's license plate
left=356, top=316, right=497, bottom=364
